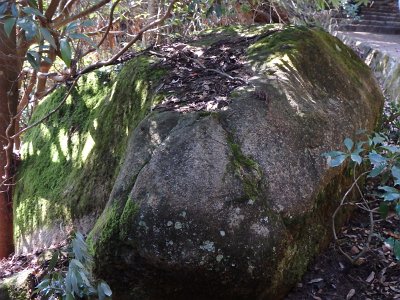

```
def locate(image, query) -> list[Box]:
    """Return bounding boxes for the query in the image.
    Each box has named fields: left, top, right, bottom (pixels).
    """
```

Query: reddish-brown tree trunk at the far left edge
left=0, top=18, right=21, bottom=259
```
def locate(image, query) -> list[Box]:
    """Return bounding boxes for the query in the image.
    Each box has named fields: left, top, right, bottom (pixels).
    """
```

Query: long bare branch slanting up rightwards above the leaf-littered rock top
left=79, top=0, right=179, bottom=75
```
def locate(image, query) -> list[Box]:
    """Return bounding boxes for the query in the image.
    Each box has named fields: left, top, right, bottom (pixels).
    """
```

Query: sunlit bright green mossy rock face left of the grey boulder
left=14, top=56, right=166, bottom=243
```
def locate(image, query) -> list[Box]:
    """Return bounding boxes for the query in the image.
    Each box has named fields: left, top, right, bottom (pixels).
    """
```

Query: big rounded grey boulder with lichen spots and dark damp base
left=91, top=28, right=383, bottom=299
